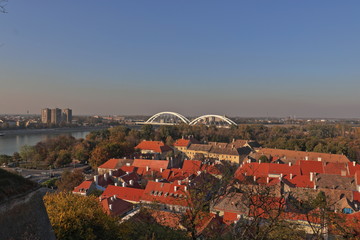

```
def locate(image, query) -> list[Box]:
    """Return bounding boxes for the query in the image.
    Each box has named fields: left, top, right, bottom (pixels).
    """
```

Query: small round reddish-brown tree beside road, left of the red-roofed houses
left=56, top=169, right=84, bottom=191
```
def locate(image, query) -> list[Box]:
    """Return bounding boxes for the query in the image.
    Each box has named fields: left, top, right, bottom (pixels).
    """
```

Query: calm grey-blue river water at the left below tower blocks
left=0, top=129, right=91, bottom=155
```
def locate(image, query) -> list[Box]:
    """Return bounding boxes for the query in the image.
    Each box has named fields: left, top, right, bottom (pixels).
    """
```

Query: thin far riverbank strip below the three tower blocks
left=0, top=126, right=108, bottom=136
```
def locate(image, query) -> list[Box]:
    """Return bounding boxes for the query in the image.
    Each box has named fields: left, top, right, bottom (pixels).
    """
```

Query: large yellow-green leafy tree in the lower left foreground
left=44, top=192, right=120, bottom=240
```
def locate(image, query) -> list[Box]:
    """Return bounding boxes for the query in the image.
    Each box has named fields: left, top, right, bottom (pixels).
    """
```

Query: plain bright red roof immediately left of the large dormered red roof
left=101, top=185, right=144, bottom=202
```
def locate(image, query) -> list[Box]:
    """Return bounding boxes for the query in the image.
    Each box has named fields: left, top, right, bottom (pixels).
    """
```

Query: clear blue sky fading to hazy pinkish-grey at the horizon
left=0, top=0, right=360, bottom=117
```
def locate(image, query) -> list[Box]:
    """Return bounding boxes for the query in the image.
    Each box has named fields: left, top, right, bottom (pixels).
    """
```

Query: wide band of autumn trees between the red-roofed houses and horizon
left=0, top=124, right=360, bottom=168
